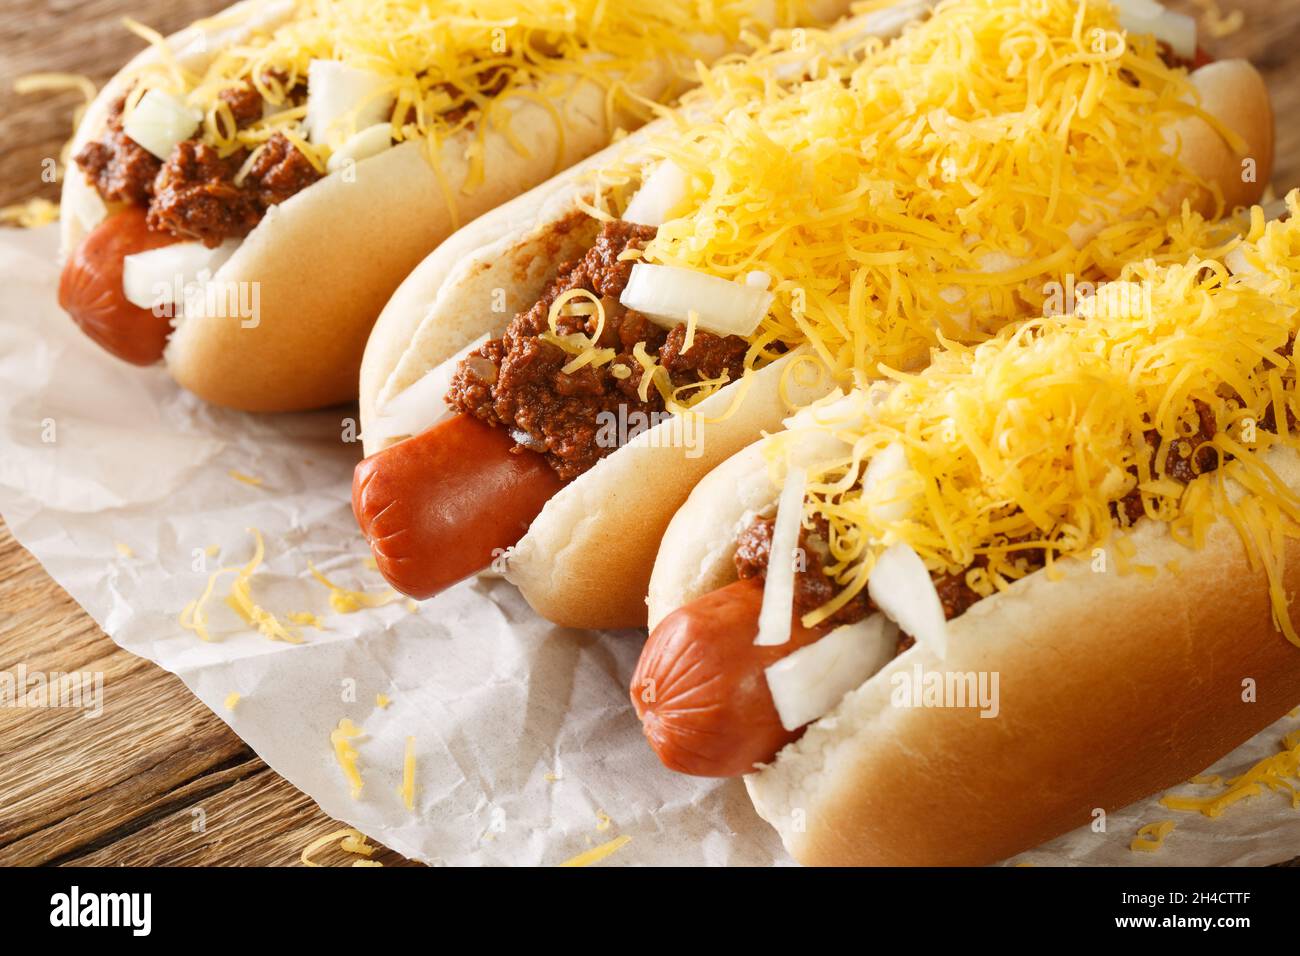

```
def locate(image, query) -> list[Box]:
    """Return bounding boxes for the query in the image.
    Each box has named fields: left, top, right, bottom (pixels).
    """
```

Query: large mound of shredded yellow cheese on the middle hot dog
left=606, top=0, right=1222, bottom=392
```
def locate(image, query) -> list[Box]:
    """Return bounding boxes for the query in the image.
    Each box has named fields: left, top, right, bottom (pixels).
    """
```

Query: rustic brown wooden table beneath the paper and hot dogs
left=0, top=0, right=1300, bottom=865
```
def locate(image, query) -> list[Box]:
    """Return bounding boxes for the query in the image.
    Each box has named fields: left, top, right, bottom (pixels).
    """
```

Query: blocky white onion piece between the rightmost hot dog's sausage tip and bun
left=763, top=614, right=898, bottom=731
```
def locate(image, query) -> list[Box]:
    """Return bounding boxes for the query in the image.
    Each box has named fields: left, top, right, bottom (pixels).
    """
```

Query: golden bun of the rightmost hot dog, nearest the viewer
left=650, top=429, right=1300, bottom=866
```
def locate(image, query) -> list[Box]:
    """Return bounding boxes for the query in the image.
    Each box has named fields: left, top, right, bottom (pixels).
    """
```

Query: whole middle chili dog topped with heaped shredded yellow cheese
left=354, top=0, right=1273, bottom=627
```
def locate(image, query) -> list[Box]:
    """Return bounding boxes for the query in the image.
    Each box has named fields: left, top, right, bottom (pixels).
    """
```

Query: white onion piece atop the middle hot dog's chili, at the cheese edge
left=619, top=263, right=774, bottom=337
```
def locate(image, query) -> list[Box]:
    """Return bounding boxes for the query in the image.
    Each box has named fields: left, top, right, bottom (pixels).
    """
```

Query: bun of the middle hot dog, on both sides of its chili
left=361, top=117, right=831, bottom=627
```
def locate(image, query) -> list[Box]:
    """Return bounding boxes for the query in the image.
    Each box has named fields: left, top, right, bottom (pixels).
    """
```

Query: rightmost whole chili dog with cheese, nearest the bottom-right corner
left=632, top=193, right=1300, bottom=865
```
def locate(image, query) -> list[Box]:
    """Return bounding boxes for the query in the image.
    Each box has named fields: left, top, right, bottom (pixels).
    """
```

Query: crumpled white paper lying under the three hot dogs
left=0, top=228, right=1300, bottom=865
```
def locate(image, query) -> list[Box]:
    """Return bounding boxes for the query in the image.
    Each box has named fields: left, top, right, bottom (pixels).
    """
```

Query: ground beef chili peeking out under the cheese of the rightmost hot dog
left=735, top=401, right=1237, bottom=654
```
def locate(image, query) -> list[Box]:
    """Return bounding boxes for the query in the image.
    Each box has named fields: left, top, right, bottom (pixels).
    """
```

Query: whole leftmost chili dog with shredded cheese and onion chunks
left=60, top=0, right=848, bottom=411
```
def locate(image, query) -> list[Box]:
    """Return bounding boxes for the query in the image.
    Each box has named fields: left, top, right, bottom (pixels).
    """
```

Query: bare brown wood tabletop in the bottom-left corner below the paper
left=0, top=523, right=416, bottom=866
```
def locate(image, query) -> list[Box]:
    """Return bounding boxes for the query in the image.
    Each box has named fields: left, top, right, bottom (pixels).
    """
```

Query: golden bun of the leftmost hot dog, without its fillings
left=62, top=0, right=848, bottom=412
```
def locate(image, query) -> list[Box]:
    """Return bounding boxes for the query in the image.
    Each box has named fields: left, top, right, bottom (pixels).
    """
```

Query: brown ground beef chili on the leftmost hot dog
left=74, top=83, right=321, bottom=246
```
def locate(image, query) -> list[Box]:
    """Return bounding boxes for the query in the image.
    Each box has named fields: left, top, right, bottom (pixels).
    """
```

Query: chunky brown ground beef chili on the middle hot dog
left=447, top=222, right=749, bottom=480
